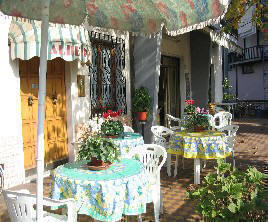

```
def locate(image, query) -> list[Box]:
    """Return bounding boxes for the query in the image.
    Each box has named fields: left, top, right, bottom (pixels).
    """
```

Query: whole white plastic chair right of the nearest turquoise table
left=130, top=144, right=167, bottom=222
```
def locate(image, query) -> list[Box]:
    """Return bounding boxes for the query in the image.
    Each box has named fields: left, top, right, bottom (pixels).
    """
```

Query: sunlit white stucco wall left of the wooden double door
left=0, top=16, right=25, bottom=188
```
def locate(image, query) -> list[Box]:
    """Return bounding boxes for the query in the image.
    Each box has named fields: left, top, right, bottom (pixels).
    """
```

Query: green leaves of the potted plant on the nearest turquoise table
left=78, top=136, right=120, bottom=163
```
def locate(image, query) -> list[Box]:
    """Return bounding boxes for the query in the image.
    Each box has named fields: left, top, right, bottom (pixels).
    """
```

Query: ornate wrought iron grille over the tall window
left=90, top=32, right=127, bottom=116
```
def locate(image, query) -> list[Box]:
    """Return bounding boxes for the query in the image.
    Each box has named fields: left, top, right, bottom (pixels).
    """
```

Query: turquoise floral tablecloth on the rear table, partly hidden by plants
left=113, top=132, right=144, bottom=158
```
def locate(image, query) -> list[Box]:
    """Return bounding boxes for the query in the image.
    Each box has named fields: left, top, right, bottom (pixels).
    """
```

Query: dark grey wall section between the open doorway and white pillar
left=190, top=31, right=210, bottom=107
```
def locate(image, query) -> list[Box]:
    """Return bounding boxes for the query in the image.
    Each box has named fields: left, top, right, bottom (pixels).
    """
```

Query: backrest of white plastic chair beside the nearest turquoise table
left=130, top=144, right=167, bottom=182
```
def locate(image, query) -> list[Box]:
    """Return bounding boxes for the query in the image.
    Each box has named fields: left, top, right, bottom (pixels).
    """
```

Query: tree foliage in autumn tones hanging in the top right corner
left=223, top=0, right=268, bottom=33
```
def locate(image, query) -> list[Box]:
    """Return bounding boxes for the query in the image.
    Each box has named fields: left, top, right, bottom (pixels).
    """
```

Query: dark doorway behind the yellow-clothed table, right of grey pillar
left=158, top=56, right=181, bottom=126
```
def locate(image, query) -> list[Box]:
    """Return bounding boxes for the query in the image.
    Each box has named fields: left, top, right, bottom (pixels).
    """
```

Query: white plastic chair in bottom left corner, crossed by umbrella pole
left=3, top=190, right=77, bottom=222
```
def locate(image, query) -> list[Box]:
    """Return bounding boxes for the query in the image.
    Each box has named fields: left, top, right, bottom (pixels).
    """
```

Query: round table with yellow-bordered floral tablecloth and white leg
left=167, top=130, right=228, bottom=184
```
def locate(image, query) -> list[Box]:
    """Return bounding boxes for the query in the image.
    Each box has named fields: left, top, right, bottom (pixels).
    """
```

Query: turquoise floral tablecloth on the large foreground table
left=51, top=159, right=152, bottom=221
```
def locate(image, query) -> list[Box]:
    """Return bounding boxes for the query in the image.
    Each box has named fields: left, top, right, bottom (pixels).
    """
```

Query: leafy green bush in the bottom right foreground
left=187, top=159, right=268, bottom=222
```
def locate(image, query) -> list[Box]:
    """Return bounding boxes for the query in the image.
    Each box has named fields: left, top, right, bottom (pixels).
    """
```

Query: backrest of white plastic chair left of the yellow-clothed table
left=151, top=126, right=174, bottom=147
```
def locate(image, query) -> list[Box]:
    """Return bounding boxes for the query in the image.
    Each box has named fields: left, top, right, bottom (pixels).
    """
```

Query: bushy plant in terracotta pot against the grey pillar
left=133, top=87, right=152, bottom=121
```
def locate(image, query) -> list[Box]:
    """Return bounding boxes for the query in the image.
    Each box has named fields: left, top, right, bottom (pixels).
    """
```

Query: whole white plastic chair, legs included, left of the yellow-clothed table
left=151, top=126, right=177, bottom=177
